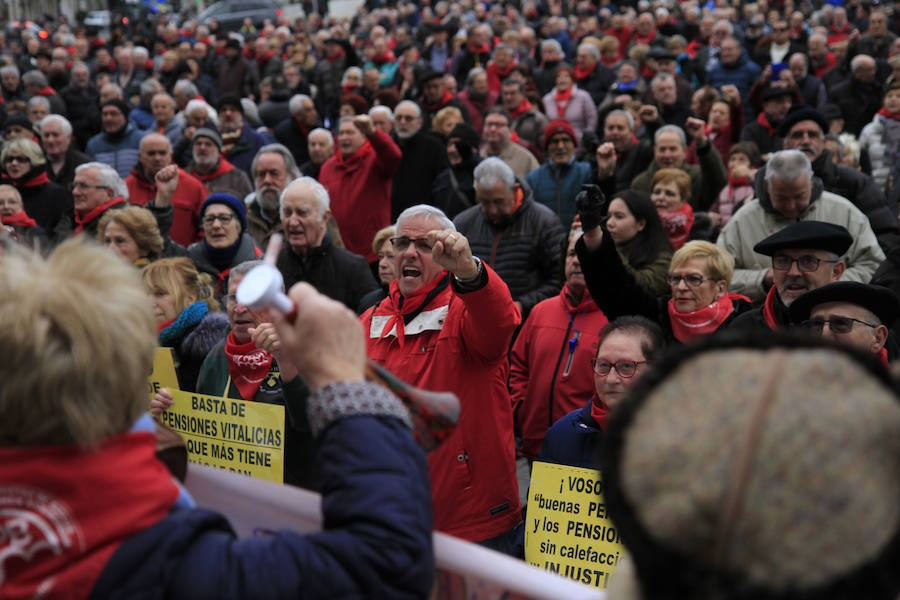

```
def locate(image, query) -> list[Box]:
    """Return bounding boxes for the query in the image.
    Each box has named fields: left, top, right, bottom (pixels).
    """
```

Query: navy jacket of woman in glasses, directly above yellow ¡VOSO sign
left=538, top=400, right=603, bottom=469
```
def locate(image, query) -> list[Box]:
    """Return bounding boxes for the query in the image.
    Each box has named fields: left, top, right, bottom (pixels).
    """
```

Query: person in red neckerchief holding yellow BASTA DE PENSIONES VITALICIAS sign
left=150, top=260, right=319, bottom=490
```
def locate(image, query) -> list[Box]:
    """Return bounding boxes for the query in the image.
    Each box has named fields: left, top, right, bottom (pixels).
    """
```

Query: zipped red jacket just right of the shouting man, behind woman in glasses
left=509, top=286, right=608, bottom=459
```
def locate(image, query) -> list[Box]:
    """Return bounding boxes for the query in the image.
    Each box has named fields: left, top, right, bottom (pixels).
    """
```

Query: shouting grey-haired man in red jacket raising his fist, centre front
left=362, top=204, right=521, bottom=553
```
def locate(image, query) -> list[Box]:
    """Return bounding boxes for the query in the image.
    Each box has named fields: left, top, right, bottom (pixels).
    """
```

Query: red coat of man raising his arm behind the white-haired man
left=319, top=129, right=400, bottom=262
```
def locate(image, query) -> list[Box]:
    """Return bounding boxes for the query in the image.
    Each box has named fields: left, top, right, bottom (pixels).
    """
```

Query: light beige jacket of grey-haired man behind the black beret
left=716, top=177, right=884, bottom=301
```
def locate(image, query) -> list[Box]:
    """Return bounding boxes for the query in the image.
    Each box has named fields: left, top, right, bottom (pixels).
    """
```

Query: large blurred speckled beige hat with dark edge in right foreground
left=602, top=334, right=900, bottom=600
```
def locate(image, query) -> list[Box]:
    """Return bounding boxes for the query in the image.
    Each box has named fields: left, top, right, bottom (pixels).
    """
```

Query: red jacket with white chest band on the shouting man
left=360, top=265, right=521, bottom=542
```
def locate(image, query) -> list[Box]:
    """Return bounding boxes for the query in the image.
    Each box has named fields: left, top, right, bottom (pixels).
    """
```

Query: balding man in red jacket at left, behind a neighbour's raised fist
left=125, top=133, right=207, bottom=248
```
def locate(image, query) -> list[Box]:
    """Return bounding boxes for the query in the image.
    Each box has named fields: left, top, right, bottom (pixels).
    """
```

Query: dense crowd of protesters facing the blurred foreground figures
left=8, top=0, right=900, bottom=596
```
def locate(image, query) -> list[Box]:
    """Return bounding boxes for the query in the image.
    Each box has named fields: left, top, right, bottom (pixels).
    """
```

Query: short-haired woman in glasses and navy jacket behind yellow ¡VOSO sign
left=538, top=317, right=666, bottom=469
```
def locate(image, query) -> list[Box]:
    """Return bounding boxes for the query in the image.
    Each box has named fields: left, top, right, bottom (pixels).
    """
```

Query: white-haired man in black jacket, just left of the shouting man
left=276, top=177, right=378, bottom=311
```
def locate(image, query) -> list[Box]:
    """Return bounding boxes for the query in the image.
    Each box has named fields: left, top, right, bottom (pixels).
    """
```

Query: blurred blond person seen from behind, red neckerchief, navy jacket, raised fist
left=0, top=240, right=435, bottom=600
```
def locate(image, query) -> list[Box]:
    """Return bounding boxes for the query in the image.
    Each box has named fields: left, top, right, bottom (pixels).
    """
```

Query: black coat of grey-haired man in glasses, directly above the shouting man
left=391, top=129, right=448, bottom=221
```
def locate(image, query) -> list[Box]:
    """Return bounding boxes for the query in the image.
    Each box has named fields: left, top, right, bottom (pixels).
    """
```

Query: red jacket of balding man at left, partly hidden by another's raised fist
left=125, top=165, right=207, bottom=248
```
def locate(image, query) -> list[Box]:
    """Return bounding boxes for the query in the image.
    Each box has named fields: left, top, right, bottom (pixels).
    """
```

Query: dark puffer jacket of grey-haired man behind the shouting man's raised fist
left=453, top=180, right=566, bottom=316
